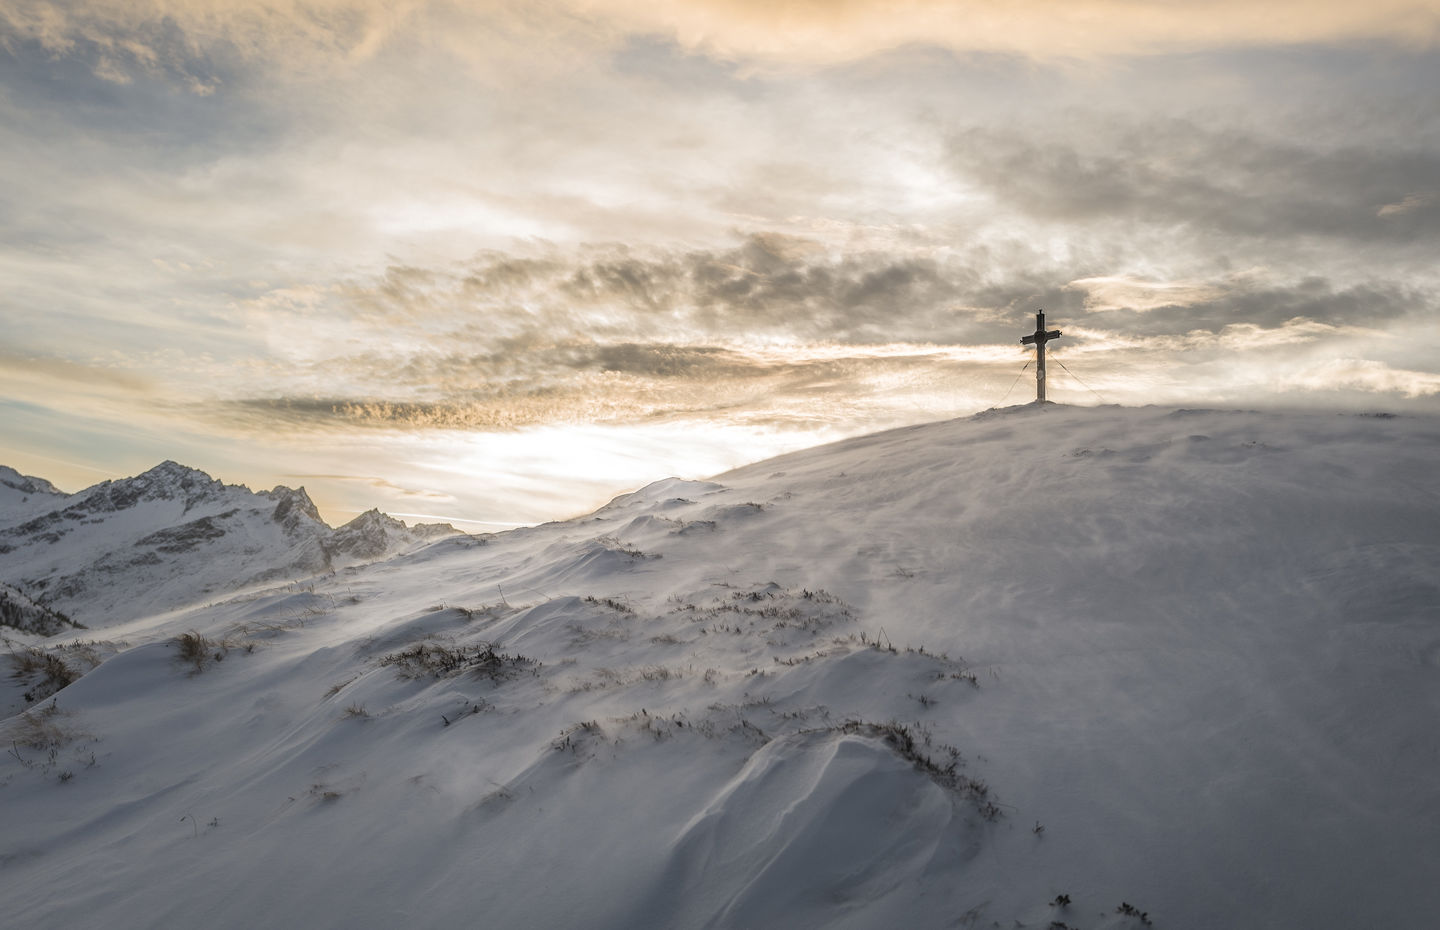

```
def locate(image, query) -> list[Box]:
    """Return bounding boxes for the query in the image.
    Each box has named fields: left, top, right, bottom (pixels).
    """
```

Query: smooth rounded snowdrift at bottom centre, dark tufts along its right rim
left=641, top=731, right=982, bottom=927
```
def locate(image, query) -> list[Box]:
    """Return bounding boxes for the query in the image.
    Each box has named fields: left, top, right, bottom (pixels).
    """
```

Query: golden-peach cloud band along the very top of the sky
left=11, top=0, right=1440, bottom=92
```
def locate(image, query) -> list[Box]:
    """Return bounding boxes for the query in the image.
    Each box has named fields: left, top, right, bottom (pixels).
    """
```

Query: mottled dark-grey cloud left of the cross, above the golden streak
left=245, top=233, right=1002, bottom=358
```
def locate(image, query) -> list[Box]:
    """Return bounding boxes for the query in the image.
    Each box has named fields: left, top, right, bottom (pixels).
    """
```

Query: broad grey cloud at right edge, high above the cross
left=949, top=117, right=1440, bottom=248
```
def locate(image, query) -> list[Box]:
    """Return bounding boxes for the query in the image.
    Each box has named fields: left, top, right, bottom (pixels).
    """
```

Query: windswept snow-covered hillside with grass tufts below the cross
left=0, top=406, right=1440, bottom=930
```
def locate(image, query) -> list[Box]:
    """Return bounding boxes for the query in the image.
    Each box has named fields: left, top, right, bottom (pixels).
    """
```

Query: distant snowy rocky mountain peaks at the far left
left=0, top=462, right=456, bottom=635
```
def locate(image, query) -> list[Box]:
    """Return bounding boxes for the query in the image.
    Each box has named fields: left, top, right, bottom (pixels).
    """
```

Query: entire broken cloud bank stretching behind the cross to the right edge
left=185, top=226, right=1433, bottom=433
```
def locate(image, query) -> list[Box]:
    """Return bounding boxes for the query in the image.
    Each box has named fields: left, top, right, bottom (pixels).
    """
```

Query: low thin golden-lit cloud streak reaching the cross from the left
left=210, top=335, right=1014, bottom=433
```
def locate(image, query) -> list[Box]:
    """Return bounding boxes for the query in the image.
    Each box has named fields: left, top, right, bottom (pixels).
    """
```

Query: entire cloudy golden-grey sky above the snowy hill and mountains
left=0, top=0, right=1440, bottom=531
